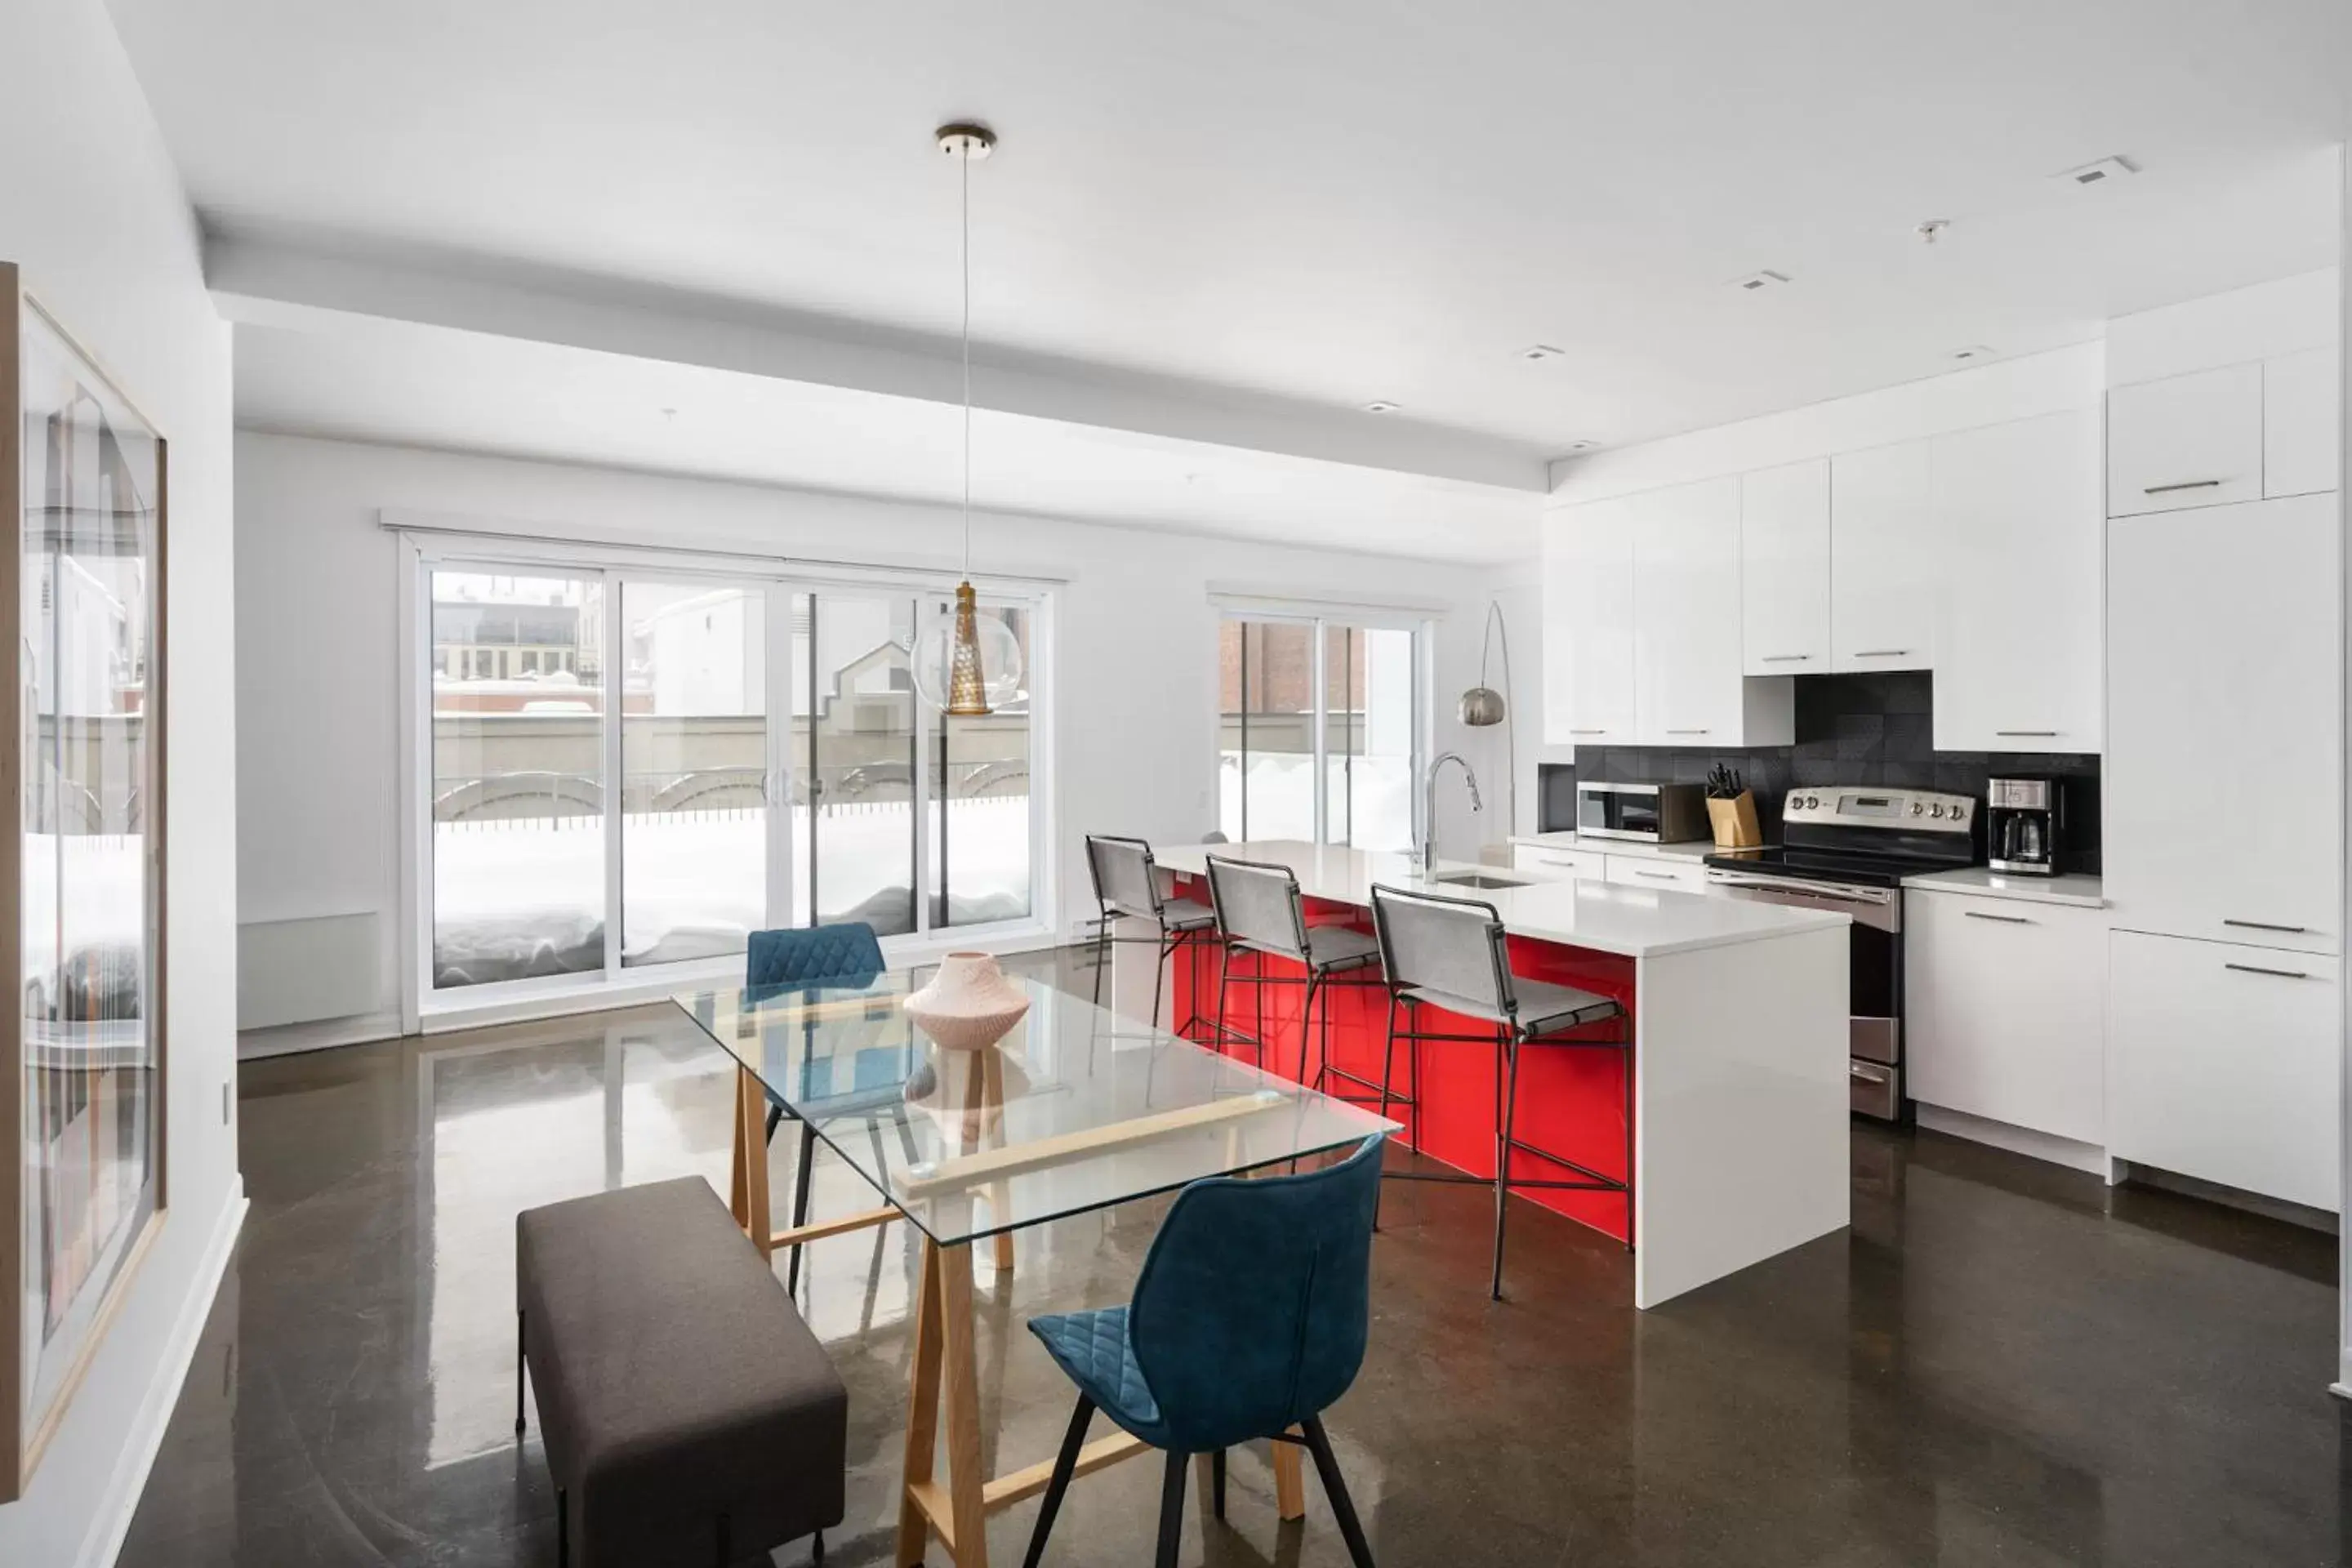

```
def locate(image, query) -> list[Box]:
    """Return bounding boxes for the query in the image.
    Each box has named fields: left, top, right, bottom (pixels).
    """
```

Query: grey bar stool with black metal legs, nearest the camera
left=1371, top=884, right=1633, bottom=1300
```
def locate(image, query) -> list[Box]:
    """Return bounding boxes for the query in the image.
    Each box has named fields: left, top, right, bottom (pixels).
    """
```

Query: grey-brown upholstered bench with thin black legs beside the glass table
left=515, top=1175, right=849, bottom=1568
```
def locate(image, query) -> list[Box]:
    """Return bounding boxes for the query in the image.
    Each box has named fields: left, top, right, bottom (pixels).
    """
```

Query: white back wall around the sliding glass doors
left=238, top=433, right=1503, bottom=1020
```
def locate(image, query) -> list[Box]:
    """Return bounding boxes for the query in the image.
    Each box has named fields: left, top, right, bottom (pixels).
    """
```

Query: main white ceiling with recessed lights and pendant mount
left=110, top=0, right=2352, bottom=541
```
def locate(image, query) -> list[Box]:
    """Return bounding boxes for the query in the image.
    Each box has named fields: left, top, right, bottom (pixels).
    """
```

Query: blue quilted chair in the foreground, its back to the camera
left=1028, top=1138, right=1383, bottom=1568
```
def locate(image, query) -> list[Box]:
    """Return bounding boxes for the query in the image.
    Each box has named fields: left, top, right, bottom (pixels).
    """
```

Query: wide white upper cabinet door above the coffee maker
left=1929, top=409, right=2103, bottom=752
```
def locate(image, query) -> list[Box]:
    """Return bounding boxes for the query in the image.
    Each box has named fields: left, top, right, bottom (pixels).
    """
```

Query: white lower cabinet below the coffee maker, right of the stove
left=1903, top=891, right=2107, bottom=1147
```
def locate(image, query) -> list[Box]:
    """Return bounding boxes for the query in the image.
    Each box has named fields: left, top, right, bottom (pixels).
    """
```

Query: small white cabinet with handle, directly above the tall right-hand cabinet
left=2107, top=359, right=2263, bottom=517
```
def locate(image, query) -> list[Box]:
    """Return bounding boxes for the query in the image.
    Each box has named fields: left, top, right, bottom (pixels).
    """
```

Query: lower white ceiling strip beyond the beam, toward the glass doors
left=238, top=322, right=1540, bottom=562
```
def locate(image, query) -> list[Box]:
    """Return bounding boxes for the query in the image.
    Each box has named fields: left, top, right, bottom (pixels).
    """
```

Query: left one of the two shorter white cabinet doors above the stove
left=1740, top=458, right=1830, bottom=675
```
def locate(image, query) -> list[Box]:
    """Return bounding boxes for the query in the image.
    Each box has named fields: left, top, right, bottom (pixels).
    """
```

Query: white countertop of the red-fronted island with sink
left=1152, top=840, right=1849, bottom=959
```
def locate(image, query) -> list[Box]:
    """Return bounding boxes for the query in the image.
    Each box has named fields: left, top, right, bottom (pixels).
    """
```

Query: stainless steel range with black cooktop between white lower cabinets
left=1708, top=785, right=1980, bottom=1121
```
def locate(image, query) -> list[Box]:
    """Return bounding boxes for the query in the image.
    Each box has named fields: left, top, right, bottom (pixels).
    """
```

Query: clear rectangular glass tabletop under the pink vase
left=675, top=973, right=1397, bottom=1246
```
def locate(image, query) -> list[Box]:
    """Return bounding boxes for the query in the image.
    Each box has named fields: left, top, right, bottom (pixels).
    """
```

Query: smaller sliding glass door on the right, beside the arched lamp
left=1218, top=616, right=1425, bottom=851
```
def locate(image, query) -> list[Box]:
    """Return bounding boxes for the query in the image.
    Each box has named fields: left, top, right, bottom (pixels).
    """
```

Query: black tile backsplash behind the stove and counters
left=1536, top=670, right=2098, bottom=872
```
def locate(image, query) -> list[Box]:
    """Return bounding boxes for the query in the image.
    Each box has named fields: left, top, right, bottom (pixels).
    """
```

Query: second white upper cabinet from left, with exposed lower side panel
left=1633, top=479, right=1797, bottom=747
